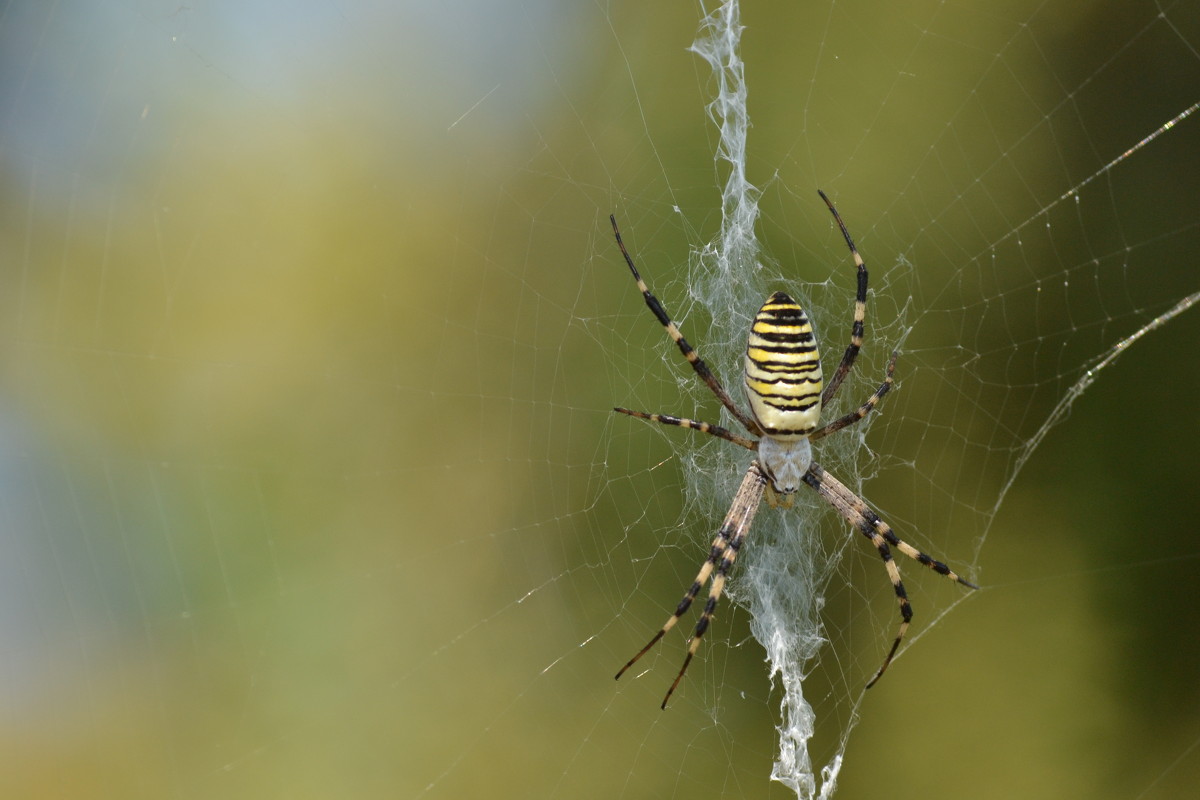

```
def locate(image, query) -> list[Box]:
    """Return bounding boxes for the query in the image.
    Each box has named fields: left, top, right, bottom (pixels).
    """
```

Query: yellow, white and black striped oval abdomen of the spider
left=745, top=291, right=822, bottom=439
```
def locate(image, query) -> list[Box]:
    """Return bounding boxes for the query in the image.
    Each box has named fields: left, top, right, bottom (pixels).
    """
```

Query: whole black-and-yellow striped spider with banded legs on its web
left=608, top=191, right=979, bottom=709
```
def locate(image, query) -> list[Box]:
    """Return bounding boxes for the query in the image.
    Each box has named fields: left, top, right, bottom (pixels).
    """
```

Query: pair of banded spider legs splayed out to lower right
left=804, top=462, right=979, bottom=688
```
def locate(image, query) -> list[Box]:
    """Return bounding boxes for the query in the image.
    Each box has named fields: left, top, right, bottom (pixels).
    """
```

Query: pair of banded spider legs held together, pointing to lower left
left=617, top=461, right=767, bottom=709
